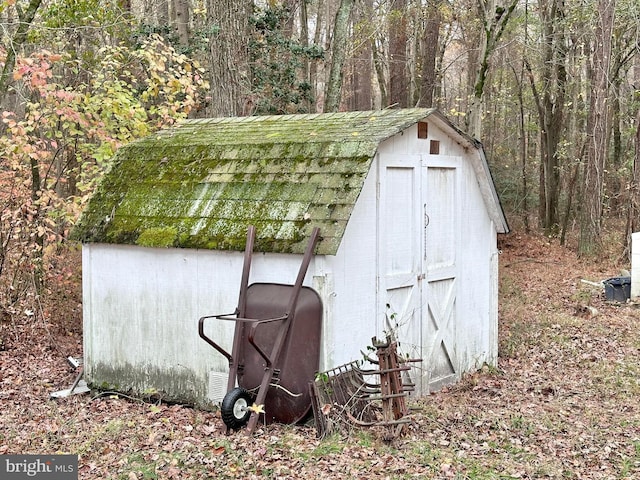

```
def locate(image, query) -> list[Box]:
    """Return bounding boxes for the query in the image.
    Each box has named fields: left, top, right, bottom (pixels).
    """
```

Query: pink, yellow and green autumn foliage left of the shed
left=0, top=35, right=208, bottom=326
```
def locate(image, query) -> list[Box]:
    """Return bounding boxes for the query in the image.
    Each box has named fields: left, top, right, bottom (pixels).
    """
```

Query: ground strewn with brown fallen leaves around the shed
left=0, top=233, right=640, bottom=480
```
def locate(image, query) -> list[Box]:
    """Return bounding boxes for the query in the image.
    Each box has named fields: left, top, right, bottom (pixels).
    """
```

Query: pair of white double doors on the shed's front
left=378, top=154, right=464, bottom=394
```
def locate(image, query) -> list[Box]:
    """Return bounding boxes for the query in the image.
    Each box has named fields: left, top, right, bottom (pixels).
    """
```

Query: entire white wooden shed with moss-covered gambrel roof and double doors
left=73, top=109, right=508, bottom=405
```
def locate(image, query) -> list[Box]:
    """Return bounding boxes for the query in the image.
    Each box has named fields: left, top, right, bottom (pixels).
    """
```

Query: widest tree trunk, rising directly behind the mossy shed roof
left=207, top=0, right=252, bottom=117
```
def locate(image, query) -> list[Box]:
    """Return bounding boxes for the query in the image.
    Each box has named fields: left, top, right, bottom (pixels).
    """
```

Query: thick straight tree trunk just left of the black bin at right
left=578, top=0, right=616, bottom=255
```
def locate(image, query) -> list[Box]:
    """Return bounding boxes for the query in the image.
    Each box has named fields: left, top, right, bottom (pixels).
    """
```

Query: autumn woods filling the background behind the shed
left=0, top=0, right=640, bottom=326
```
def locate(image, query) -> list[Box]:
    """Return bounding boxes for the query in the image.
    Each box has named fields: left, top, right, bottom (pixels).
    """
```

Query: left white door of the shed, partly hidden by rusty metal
left=378, top=155, right=423, bottom=392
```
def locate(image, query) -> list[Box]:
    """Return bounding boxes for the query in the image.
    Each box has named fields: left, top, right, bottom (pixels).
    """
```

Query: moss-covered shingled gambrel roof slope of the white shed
left=72, top=109, right=444, bottom=254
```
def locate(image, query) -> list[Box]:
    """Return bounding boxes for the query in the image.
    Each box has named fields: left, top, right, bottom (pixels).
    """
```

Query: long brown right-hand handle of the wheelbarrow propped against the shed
left=247, top=227, right=320, bottom=434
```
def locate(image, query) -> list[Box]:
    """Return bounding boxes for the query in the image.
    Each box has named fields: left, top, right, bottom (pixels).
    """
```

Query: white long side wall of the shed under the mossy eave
left=82, top=244, right=322, bottom=403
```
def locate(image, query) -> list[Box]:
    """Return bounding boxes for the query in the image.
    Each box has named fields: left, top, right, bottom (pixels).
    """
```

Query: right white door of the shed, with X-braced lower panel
left=422, top=155, right=462, bottom=391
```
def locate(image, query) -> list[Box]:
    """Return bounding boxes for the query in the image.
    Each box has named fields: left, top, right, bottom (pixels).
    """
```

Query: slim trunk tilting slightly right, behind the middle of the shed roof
left=324, top=0, right=354, bottom=112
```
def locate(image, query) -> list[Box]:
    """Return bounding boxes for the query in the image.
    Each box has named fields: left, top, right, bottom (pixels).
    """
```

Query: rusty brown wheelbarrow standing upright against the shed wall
left=198, top=226, right=322, bottom=433
